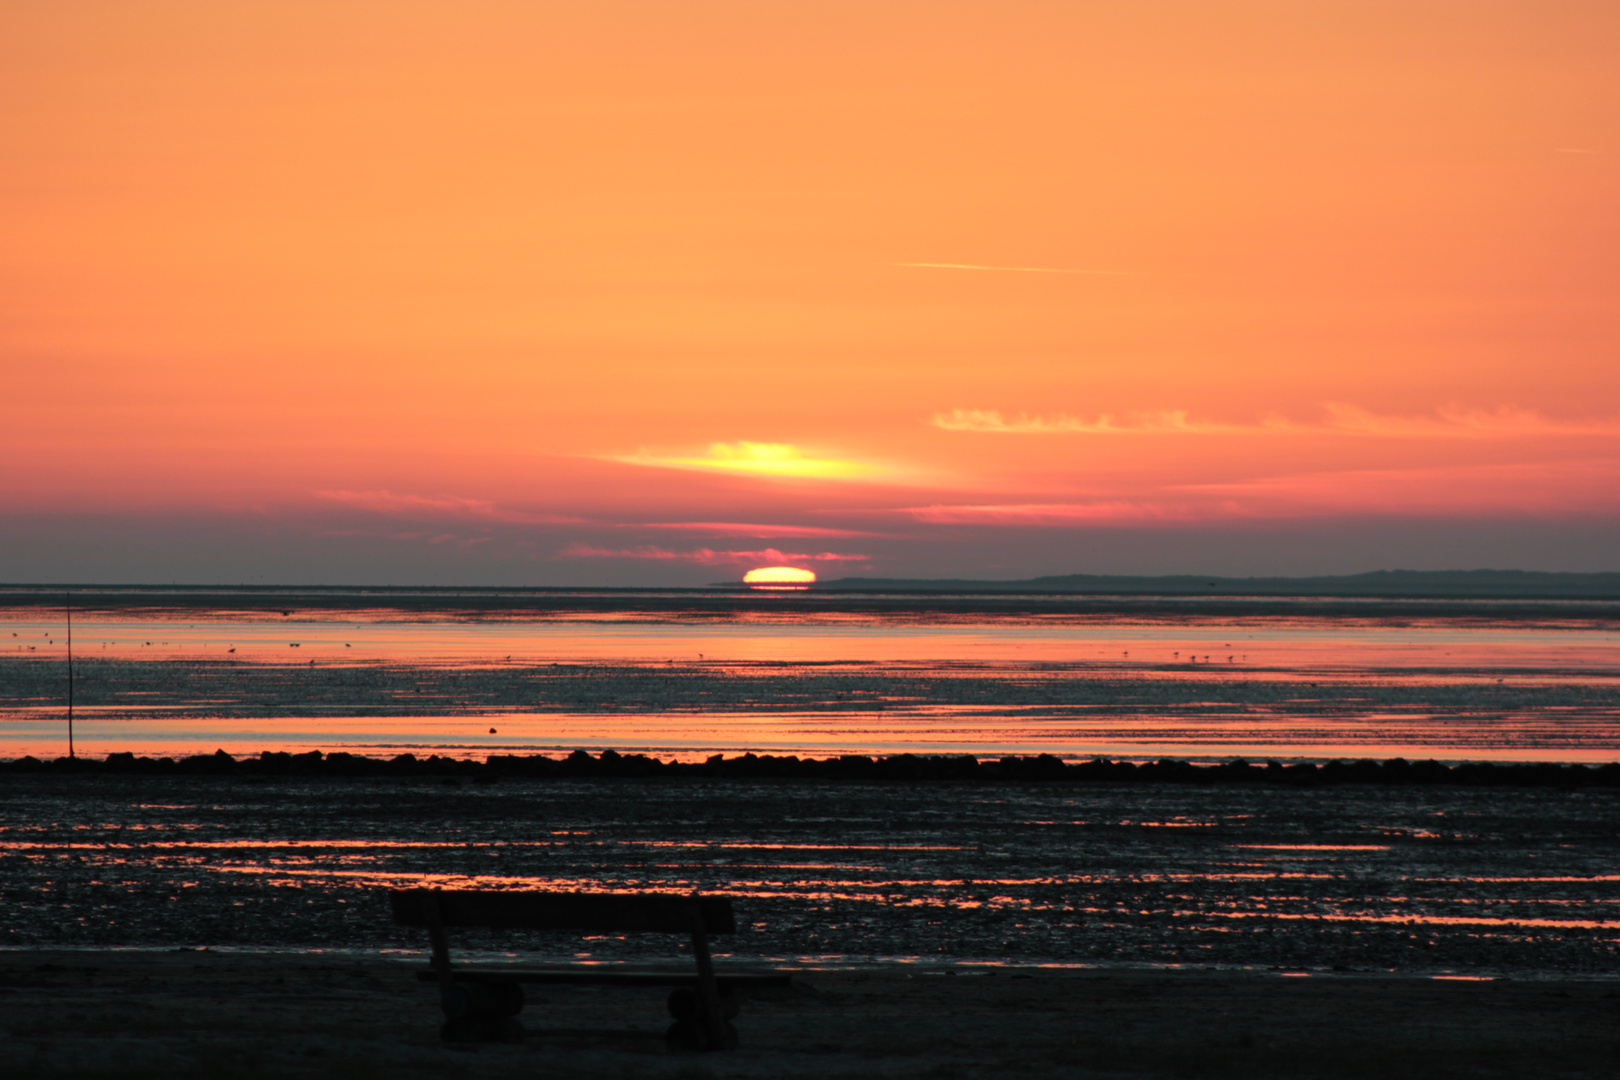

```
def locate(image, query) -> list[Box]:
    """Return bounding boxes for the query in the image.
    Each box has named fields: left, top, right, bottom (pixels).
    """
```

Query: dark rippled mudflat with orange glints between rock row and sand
left=0, top=774, right=1620, bottom=978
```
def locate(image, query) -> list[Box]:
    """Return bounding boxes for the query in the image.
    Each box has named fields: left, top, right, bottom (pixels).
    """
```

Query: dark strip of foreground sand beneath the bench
left=0, top=950, right=1620, bottom=1080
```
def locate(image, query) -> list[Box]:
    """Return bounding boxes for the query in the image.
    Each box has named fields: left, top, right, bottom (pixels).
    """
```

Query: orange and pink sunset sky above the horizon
left=0, top=0, right=1620, bottom=585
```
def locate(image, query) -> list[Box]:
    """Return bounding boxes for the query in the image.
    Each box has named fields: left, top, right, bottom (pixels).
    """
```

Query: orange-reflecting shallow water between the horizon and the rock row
left=0, top=589, right=1620, bottom=763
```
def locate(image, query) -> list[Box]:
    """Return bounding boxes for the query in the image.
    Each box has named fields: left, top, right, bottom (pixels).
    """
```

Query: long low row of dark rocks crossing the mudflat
left=9, top=750, right=1620, bottom=790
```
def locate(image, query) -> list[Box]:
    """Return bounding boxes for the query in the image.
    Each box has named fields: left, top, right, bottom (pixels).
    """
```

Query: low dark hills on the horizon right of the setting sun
left=815, top=570, right=1620, bottom=601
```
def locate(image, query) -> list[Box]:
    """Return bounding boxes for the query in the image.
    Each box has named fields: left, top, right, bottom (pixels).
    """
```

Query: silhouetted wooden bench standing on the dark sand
left=389, top=889, right=792, bottom=1049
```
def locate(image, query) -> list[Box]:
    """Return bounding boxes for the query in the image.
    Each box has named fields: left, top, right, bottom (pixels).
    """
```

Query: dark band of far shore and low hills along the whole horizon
left=0, top=572, right=1620, bottom=628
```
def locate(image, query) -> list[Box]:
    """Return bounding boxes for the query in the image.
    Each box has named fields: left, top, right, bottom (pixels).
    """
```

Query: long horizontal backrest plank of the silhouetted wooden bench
left=389, top=889, right=737, bottom=934
